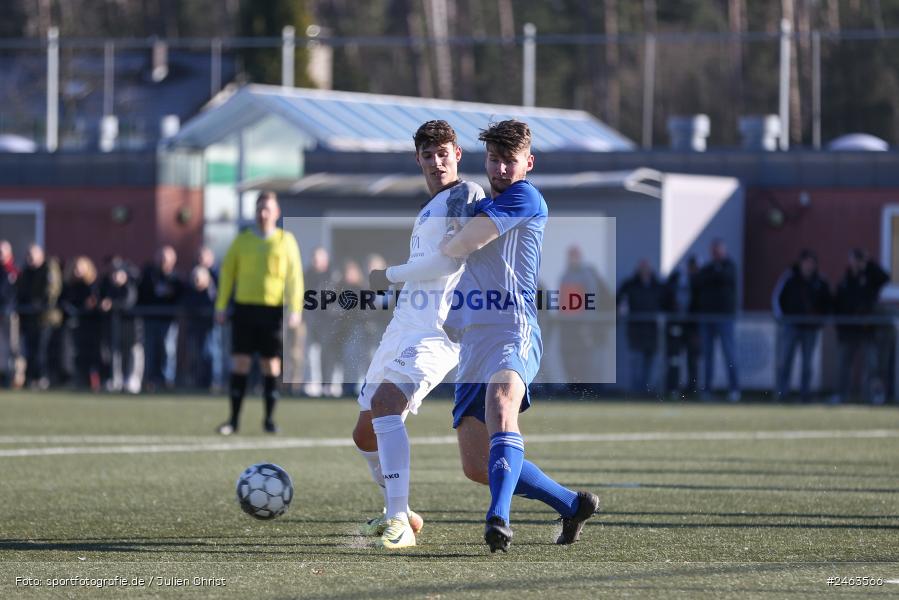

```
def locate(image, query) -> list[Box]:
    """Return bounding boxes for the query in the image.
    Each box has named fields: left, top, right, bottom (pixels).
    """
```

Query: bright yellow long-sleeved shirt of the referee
left=215, top=228, right=303, bottom=313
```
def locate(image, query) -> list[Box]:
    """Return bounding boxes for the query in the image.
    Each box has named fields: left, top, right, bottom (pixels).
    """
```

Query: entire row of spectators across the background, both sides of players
left=0, top=239, right=895, bottom=403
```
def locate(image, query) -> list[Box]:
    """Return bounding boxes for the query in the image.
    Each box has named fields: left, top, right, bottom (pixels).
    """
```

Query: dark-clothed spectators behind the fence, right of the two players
left=617, top=239, right=895, bottom=404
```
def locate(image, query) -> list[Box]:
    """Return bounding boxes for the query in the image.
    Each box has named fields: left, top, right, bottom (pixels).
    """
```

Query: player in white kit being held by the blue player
left=353, top=120, right=485, bottom=549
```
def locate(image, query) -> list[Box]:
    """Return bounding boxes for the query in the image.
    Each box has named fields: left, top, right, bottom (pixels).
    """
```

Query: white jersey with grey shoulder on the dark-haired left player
left=391, top=181, right=484, bottom=333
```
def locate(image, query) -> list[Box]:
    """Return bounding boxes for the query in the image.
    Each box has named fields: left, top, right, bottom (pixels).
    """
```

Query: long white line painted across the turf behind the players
left=0, top=429, right=899, bottom=458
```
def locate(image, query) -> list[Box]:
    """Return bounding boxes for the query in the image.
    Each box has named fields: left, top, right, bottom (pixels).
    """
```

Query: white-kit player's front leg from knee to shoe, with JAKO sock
left=371, top=381, right=415, bottom=548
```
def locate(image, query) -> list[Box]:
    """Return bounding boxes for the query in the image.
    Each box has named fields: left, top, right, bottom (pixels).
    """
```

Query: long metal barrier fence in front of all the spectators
left=0, top=309, right=899, bottom=404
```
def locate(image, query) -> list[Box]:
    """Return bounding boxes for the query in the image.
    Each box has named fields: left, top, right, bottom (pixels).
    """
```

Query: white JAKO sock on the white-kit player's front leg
left=371, top=415, right=411, bottom=519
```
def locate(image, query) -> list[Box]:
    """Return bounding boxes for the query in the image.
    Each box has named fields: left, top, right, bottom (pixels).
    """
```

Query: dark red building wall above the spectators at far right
left=743, top=188, right=899, bottom=310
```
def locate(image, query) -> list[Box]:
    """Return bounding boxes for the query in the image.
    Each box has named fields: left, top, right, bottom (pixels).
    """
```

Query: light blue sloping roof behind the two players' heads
left=171, top=85, right=636, bottom=152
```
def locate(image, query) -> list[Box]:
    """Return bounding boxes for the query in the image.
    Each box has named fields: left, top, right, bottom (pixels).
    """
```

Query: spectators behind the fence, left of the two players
left=0, top=240, right=390, bottom=396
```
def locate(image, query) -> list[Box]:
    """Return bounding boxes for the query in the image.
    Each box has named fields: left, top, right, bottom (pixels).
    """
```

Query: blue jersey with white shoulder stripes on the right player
left=446, top=180, right=549, bottom=331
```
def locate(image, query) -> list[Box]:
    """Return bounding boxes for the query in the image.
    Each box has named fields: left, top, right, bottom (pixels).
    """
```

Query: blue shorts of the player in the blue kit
left=453, top=325, right=543, bottom=429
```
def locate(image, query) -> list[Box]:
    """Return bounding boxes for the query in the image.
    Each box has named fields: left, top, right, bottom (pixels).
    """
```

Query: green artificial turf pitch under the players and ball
left=0, top=393, right=899, bottom=599
